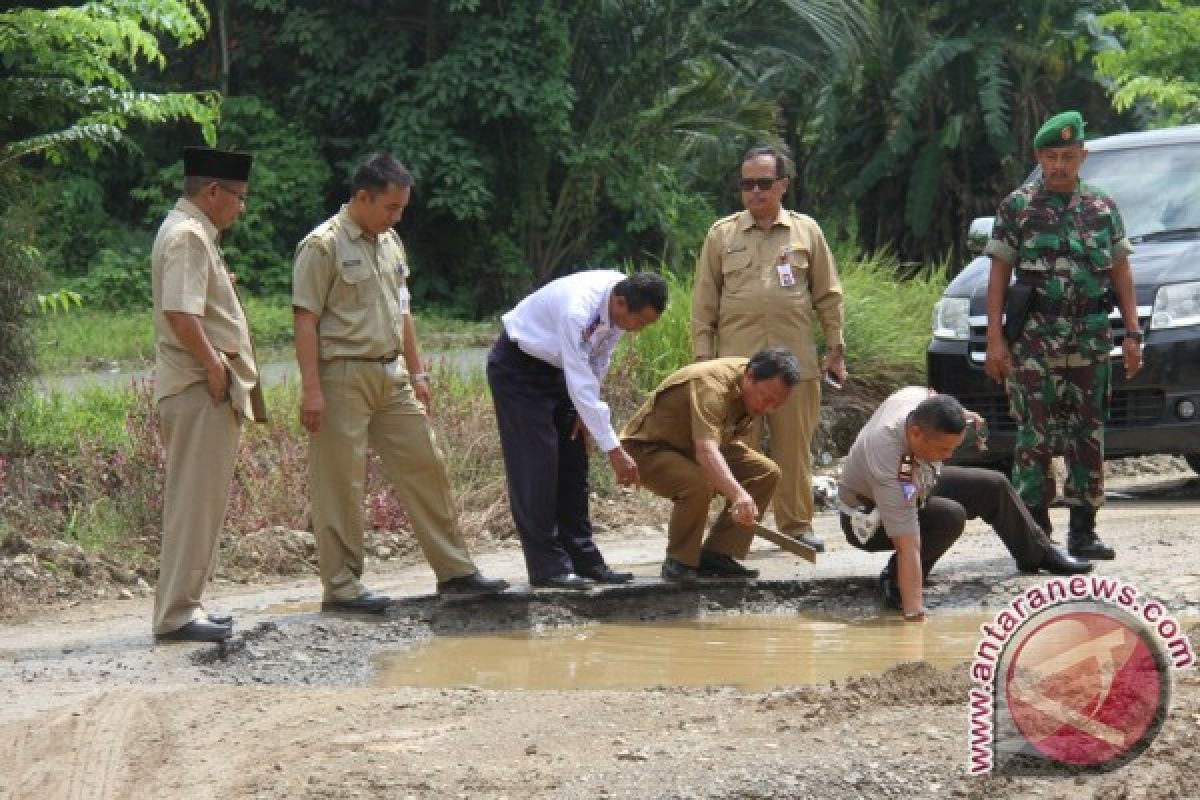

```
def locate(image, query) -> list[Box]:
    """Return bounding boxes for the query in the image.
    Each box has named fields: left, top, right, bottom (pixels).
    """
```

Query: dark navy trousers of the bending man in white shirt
left=487, top=333, right=605, bottom=581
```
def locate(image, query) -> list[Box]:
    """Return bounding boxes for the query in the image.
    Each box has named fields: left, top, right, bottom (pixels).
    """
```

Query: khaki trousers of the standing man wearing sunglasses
left=748, top=380, right=821, bottom=533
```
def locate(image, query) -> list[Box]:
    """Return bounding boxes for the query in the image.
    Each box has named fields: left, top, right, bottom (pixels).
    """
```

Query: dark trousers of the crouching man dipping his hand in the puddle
left=841, top=467, right=1050, bottom=577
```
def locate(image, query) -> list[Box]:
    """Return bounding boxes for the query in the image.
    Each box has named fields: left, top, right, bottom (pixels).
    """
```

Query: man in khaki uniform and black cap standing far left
left=151, top=148, right=258, bottom=642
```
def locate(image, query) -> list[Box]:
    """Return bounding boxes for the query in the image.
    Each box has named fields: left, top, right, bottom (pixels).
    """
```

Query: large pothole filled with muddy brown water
left=206, top=579, right=1012, bottom=691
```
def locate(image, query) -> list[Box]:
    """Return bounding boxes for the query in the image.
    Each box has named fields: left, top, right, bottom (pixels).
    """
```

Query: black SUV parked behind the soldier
left=926, top=125, right=1200, bottom=471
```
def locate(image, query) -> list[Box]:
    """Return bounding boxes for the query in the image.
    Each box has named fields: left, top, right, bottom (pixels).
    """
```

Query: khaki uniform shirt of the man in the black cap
left=150, top=198, right=258, bottom=420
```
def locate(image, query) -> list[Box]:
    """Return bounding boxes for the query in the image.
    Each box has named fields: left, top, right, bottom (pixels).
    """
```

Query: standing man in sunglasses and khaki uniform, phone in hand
left=691, top=148, right=846, bottom=552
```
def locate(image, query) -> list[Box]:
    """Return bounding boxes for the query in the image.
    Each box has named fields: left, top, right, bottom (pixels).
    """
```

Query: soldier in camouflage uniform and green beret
left=984, top=112, right=1142, bottom=559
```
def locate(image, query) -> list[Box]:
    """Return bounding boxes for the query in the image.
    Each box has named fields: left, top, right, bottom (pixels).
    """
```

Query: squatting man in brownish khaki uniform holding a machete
left=620, top=348, right=800, bottom=583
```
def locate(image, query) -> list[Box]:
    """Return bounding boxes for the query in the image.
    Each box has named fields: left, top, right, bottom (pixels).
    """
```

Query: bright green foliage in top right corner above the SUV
left=1093, top=0, right=1200, bottom=126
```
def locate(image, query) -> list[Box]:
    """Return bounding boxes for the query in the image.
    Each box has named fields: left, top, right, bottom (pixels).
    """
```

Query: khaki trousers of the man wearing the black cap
left=154, top=384, right=241, bottom=633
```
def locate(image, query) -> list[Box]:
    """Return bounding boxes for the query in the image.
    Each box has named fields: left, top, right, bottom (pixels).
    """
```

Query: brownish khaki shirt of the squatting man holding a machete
left=620, top=359, right=751, bottom=457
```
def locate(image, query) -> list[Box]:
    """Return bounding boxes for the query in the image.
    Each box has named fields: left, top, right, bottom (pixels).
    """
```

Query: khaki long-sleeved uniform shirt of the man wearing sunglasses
left=691, top=209, right=844, bottom=380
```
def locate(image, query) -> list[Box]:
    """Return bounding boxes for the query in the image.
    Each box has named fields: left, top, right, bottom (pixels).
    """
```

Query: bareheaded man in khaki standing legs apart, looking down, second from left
left=292, top=154, right=509, bottom=614
